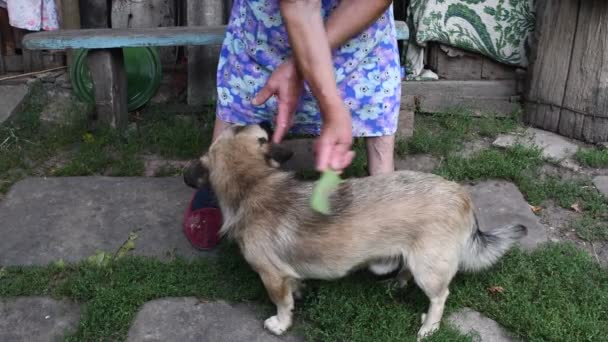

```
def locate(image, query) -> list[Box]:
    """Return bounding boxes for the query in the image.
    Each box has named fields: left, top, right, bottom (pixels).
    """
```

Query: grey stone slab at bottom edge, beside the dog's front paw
left=127, top=297, right=303, bottom=342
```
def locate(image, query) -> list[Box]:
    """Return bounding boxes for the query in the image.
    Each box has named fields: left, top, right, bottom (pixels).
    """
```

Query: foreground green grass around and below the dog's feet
left=0, top=244, right=608, bottom=341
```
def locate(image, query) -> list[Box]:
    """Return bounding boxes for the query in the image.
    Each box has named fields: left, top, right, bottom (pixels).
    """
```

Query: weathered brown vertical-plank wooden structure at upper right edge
left=524, top=0, right=608, bottom=142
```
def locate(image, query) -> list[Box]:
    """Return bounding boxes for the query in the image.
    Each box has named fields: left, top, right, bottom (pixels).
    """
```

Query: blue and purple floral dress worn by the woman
left=217, top=0, right=401, bottom=137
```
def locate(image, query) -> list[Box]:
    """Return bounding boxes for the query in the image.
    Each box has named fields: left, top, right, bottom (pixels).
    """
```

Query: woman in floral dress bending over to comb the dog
left=185, top=0, right=401, bottom=248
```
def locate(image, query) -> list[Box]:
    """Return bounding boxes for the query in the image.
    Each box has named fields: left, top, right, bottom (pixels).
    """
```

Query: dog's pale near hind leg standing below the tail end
left=408, top=255, right=458, bottom=340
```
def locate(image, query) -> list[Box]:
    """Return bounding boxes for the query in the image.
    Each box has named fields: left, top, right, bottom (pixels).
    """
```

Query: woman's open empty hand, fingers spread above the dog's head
left=253, top=58, right=304, bottom=143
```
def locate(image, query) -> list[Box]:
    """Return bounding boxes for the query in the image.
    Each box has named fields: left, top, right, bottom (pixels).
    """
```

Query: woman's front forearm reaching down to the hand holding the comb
left=280, top=0, right=343, bottom=116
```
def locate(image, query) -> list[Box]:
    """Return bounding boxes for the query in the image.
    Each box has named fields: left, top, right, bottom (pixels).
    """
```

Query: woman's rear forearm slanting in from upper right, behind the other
left=325, top=0, right=392, bottom=50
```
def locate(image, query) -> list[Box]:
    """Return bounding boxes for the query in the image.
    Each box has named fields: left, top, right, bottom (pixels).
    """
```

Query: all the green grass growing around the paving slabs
left=0, top=88, right=608, bottom=341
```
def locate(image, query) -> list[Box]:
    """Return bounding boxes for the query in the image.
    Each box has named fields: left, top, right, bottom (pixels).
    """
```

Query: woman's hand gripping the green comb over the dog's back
left=315, top=101, right=355, bottom=172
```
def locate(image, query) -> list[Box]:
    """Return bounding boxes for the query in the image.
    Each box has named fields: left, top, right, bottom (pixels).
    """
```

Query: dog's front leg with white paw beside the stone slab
left=260, top=272, right=293, bottom=335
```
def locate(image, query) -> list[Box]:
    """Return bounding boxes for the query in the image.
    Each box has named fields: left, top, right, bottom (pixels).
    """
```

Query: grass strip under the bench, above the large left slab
left=0, top=85, right=212, bottom=193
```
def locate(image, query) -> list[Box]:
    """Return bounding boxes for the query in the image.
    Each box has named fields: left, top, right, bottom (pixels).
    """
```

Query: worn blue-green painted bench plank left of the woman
left=23, top=25, right=226, bottom=50
